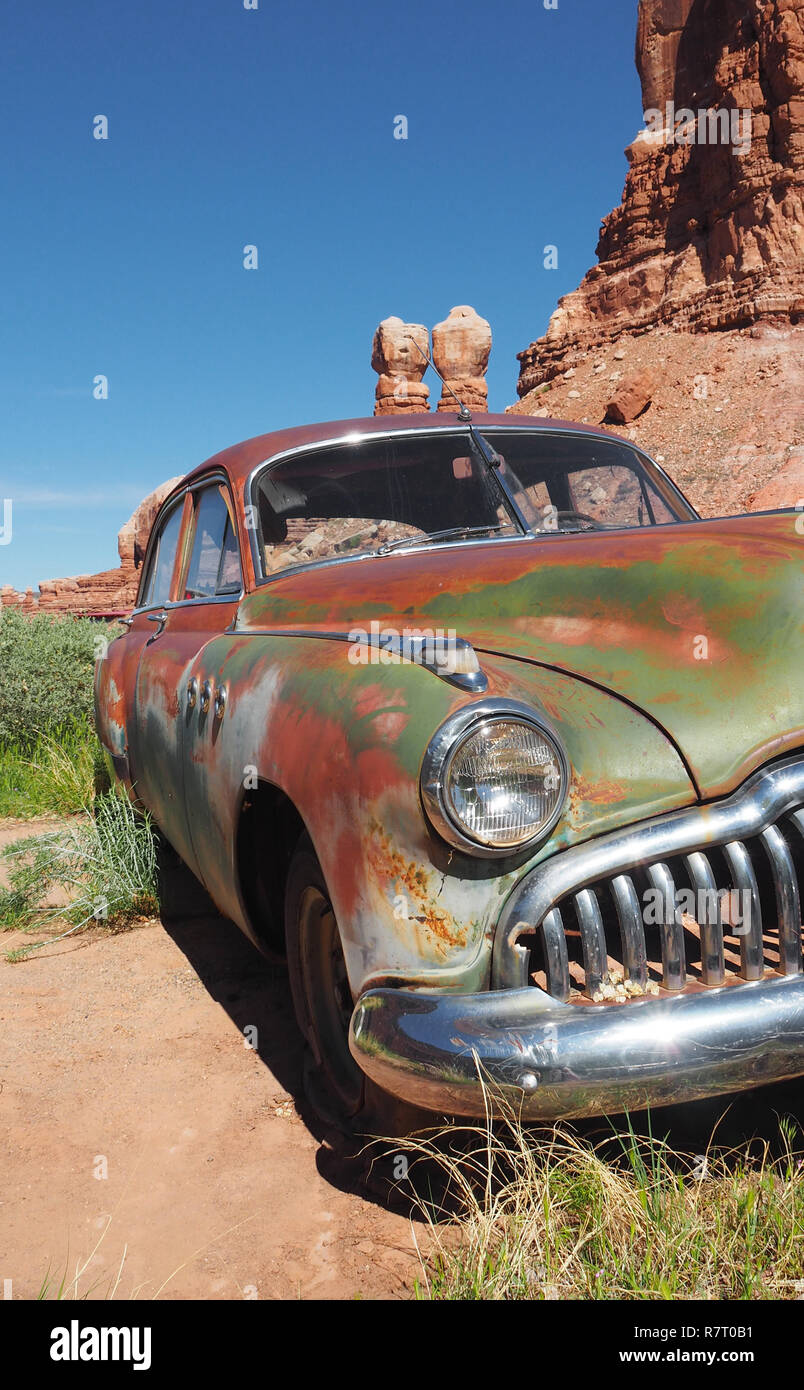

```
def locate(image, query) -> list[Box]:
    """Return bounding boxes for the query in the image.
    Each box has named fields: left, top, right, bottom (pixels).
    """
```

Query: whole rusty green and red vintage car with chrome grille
left=96, top=414, right=804, bottom=1122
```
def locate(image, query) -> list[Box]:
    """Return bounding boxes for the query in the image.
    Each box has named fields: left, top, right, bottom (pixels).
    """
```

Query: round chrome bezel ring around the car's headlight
left=420, top=699, right=570, bottom=859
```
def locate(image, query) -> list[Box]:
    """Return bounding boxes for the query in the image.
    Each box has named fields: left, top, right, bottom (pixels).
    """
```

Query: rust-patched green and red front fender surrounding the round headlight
left=185, top=634, right=696, bottom=997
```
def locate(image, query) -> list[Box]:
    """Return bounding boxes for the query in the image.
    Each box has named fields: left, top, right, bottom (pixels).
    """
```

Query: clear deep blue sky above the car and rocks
left=0, top=0, right=641, bottom=588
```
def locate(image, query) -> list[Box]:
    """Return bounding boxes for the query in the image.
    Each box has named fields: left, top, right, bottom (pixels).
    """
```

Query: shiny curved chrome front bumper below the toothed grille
left=349, top=974, right=804, bottom=1120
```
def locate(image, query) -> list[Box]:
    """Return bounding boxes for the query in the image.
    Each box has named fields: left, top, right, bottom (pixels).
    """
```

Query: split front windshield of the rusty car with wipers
left=252, top=430, right=696, bottom=577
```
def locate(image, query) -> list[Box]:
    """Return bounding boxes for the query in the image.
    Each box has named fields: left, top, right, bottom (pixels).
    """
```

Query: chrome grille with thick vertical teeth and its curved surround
left=494, top=758, right=804, bottom=1002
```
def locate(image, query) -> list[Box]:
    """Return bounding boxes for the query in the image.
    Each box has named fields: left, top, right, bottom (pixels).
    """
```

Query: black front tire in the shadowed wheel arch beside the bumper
left=285, top=834, right=427, bottom=1136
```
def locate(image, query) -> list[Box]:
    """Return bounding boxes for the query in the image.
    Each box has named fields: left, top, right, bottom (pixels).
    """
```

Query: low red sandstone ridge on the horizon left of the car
left=0, top=478, right=181, bottom=617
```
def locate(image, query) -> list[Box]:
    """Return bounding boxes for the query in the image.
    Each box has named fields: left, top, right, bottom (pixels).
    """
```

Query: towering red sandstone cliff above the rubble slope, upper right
left=517, top=0, right=804, bottom=396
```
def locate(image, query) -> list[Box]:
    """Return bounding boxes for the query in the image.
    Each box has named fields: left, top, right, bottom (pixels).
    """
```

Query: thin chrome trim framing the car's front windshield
left=243, top=421, right=695, bottom=588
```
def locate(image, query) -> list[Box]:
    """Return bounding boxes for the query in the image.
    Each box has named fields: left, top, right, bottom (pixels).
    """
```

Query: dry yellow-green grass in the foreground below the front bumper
left=394, top=1102, right=804, bottom=1300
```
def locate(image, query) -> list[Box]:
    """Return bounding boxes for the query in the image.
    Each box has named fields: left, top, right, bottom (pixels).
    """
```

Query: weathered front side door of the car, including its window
left=135, top=474, right=242, bottom=877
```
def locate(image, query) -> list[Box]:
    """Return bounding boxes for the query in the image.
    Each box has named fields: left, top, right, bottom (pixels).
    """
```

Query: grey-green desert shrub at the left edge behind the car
left=0, top=607, right=114, bottom=752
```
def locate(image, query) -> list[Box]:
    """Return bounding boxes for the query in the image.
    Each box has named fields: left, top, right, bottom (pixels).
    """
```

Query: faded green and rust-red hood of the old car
left=238, top=513, right=804, bottom=796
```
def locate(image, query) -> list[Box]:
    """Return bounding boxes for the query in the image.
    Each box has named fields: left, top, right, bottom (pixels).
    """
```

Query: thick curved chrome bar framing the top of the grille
left=491, top=753, right=804, bottom=990
